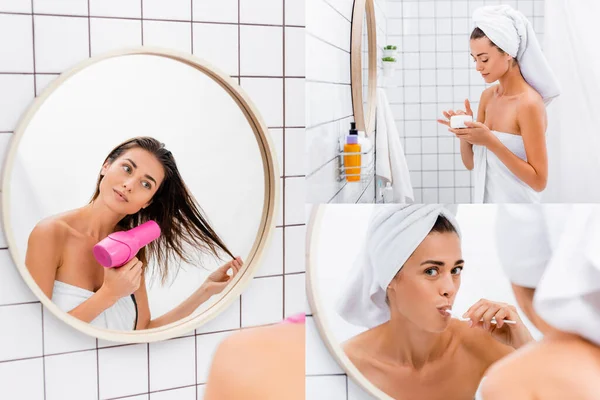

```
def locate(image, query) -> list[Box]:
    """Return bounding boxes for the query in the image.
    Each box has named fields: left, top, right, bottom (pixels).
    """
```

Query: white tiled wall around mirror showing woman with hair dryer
left=0, top=0, right=305, bottom=400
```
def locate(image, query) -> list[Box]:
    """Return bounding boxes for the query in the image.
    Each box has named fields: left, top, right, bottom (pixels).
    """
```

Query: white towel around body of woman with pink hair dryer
left=52, top=281, right=136, bottom=331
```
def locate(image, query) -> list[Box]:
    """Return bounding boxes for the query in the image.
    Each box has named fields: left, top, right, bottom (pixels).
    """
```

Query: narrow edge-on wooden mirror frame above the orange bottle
left=350, top=0, right=377, bottom=136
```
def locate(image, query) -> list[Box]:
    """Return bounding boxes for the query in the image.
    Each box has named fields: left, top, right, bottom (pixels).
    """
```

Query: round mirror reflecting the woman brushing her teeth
left=307, top=204, right=541, bottom=399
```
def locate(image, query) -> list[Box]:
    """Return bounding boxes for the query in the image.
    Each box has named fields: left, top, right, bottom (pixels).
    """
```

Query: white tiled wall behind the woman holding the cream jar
left=387, top=0, right=544, bottom=203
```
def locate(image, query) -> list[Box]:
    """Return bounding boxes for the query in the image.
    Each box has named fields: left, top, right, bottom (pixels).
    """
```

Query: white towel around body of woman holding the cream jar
left=473, top=131, right=541, bottom=203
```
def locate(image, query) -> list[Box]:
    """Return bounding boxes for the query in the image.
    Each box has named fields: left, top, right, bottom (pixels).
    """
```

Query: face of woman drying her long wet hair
left=100, top=147, right=165, bottom=215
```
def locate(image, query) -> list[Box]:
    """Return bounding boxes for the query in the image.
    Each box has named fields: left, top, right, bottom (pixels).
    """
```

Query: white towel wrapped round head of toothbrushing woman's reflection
left=337, top=204, right=460, bottom=328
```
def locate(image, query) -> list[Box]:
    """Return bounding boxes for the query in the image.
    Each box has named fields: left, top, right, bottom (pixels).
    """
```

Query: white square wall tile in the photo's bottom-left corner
left=0, top=358, right=44, bottom=399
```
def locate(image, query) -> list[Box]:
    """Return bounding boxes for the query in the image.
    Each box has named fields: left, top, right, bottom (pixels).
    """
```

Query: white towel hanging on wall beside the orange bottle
left=375, top=88, right=414, bottom=203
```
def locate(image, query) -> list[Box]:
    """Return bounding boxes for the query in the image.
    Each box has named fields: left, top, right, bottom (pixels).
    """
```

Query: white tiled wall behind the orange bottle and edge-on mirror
left=306, top=0, right=386, bottom=203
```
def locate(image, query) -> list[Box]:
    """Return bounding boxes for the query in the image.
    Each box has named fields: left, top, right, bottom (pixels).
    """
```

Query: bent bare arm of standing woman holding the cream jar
left=488, top=101, right=548, bottom=192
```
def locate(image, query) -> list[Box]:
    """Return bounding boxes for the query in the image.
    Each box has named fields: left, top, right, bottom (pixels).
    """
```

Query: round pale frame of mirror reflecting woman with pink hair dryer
left=2, top=46, right=280, bottom=343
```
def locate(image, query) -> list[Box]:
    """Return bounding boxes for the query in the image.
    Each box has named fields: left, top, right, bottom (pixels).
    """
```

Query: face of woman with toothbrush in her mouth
left=388, top=232, right=464, bottom=332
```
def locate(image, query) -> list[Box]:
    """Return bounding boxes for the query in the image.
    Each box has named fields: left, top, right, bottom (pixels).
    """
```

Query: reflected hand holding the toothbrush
left=463, top=299, right=533, bottom=349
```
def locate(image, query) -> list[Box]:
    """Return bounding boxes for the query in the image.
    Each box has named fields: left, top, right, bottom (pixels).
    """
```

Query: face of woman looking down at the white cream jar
left=471, top=37, right=512, bottom=83
